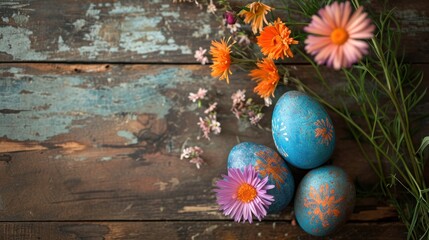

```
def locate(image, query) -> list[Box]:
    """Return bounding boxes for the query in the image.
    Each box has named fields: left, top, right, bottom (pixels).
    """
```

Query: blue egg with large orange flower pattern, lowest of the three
left=294, top=166, right=356, bottom=236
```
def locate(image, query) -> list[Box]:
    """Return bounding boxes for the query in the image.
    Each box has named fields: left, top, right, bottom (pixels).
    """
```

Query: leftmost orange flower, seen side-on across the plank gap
left=210, top=39, right=234, bottom=83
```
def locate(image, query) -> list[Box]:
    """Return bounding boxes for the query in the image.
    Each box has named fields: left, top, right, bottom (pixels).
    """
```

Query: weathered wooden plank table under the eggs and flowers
left=0, top=0, right=429, bottom=239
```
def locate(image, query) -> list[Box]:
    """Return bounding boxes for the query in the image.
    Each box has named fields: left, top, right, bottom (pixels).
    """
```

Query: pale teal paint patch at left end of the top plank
left=0, top=26, right=47, bottom=60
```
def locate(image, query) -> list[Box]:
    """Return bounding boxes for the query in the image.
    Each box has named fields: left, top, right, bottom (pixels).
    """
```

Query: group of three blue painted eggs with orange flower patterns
left=228, top=91, right=356, bottom=236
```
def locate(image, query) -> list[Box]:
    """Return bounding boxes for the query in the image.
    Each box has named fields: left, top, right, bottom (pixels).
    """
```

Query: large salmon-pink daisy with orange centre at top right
left=304, top=1, right=375, bottom=70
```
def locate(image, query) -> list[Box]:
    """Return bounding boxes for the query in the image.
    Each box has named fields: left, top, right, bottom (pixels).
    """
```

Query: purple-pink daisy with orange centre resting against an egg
left=214, top=165, right=274, bottom=223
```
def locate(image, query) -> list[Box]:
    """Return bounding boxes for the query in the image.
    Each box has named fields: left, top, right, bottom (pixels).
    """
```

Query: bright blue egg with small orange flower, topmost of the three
left=272, top=91, right=335, bottom=169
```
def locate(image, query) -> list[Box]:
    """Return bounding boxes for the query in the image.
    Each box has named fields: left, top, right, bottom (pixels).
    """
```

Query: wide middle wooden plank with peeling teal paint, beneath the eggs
left=0, top=64, right=427, bottom=221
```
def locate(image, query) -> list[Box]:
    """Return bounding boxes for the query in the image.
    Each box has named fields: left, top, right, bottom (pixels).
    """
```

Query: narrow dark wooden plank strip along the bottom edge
left=0, top=221, right=406, bottom=240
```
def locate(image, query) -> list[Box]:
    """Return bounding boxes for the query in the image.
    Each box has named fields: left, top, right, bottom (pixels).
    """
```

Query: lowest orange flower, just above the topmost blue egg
left=249, top=58, right=280, bottom=98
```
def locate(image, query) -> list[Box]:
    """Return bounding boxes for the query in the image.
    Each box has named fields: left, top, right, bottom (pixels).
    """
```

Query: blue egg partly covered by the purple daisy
left=228, top=142, right=295, bottom=213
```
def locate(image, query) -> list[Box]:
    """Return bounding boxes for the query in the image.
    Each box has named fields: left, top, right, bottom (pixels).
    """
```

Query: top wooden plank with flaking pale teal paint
left=0, top=0, right=429, bottom=63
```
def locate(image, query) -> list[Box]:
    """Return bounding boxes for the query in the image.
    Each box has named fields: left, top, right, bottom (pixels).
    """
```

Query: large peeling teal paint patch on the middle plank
left=0, top=68, right=194, bottom=141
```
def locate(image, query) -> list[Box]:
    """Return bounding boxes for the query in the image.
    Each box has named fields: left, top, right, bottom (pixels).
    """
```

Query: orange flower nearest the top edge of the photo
left=238, top=2, right=273, bottom=34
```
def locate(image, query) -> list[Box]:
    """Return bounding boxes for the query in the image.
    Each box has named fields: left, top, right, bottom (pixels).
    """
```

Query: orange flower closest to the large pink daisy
left=258, top=18, right=298, bottom=60
